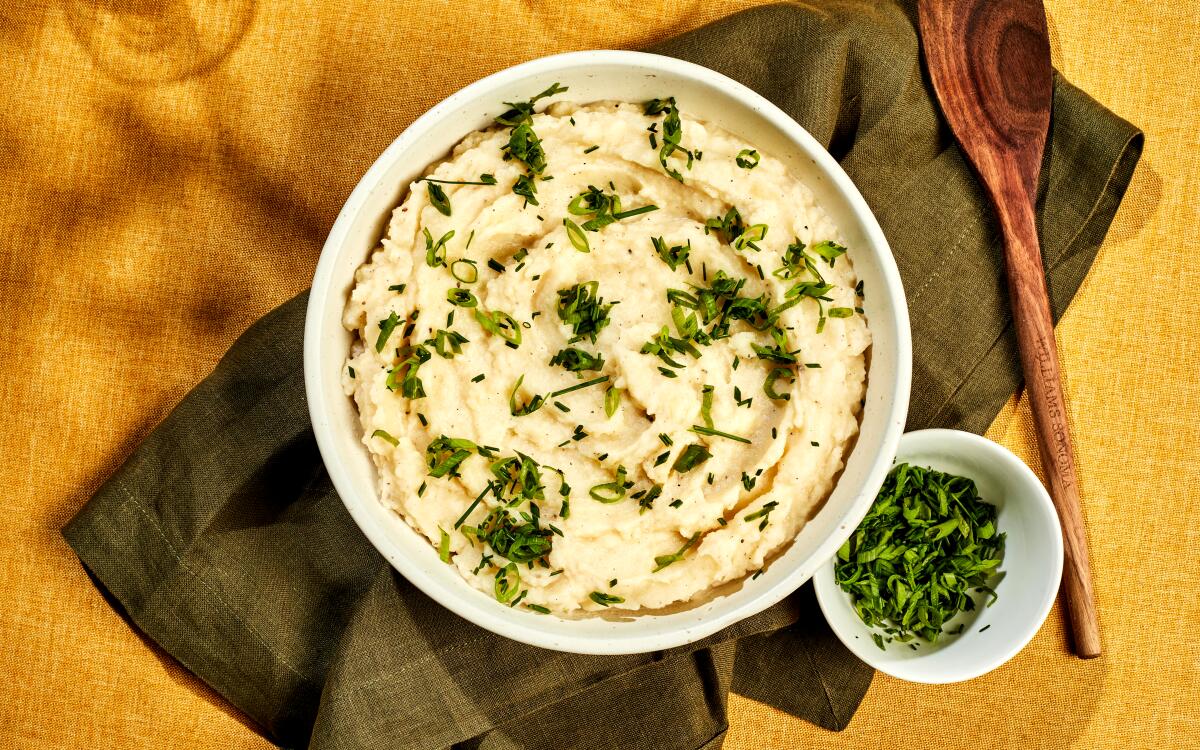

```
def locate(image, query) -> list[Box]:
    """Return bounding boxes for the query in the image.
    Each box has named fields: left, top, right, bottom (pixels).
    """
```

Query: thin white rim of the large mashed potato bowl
left=304, top=49, right=912, bottom=654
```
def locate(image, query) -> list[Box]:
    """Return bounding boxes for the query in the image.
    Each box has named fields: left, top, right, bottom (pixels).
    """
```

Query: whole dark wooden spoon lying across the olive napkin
left=918, top=0, right=1100, bottom=659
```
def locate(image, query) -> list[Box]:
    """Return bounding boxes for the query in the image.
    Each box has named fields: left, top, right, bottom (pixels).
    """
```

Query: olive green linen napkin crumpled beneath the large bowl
left=64, top=2, right=1141, bottom=750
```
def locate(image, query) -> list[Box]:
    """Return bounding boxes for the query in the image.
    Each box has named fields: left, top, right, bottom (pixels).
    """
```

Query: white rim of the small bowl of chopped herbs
left=812, top=427, right=1063, bottom=685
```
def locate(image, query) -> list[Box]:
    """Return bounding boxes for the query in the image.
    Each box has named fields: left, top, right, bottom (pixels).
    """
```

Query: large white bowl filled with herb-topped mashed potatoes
left=305, top=52, right=911, bottom=654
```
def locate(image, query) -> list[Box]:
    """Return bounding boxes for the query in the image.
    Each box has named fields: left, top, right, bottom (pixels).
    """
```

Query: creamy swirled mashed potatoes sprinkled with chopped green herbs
left=344, top=90, right=870, bottom=613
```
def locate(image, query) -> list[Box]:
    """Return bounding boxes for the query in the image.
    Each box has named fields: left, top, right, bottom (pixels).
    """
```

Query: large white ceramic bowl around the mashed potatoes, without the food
left=304, top=50, right=912, bottom=654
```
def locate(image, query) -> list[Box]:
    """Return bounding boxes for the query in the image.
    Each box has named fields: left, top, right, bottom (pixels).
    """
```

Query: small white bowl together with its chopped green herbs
left=812, top=430, right=1063, bottom=684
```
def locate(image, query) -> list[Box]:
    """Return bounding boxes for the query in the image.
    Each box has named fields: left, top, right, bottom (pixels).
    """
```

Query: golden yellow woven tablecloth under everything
left=0, top=0, right=1200, bottom=750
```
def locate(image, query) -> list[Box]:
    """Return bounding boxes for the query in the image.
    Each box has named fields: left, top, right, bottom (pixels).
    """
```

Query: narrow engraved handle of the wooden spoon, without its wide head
left=997, top=197, right=1100, bottom=659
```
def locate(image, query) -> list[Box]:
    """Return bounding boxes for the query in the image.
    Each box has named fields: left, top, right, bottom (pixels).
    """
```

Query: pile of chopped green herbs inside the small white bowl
left=834, top=463, right=1004, bottom=648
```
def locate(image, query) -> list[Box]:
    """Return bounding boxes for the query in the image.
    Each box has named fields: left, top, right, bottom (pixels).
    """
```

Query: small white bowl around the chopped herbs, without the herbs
left=812, top=430, right=1062, bottom=684
